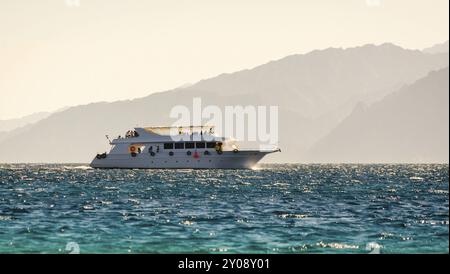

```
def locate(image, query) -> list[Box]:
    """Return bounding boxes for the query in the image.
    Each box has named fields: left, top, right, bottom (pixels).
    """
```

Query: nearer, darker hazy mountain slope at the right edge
left=309, top=68, right=449, bottom=163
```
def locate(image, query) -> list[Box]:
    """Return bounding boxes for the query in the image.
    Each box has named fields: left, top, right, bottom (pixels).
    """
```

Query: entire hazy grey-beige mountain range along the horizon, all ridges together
left=0, top=44, right=449, bottom=162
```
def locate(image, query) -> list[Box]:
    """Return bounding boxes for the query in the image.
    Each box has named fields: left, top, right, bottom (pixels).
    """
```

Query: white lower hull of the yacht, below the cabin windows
left=91, top=151, right=271, bottom=169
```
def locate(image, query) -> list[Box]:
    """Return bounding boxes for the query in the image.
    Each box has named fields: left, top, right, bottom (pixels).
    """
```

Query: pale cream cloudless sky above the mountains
left=0, top=0, right=449, bottom=119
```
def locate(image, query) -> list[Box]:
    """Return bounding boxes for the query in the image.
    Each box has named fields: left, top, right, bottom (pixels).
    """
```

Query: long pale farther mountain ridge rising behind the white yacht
left=0, top=44, right=448, bottom=162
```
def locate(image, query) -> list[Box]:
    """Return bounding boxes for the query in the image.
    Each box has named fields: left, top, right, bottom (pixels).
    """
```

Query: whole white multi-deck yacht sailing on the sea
left=91, top=126, right=280, bottom=169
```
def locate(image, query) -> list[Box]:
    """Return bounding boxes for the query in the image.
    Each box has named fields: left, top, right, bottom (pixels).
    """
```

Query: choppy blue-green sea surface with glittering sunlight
left=0, top=165, right=449, bottom=253
